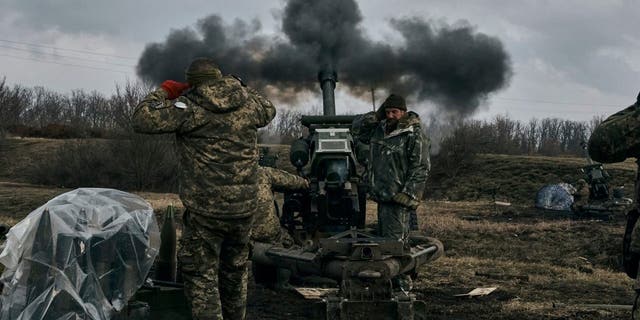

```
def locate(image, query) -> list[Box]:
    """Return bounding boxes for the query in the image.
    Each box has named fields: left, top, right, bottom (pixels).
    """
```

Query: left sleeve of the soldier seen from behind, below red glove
left=132, top=89, right=191, bottom=133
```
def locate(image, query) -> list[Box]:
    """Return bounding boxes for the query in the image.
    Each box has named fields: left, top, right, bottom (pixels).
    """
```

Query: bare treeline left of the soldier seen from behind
left=0, top=78, right=148, bottom=138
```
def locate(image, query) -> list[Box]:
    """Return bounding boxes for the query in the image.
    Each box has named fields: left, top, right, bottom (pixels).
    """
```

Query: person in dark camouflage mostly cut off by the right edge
left=589, top=94, right=640, bottom=319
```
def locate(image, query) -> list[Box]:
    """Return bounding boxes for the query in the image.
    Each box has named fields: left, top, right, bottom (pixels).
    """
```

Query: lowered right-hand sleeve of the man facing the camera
left=402, top=129, right=431, bottom=200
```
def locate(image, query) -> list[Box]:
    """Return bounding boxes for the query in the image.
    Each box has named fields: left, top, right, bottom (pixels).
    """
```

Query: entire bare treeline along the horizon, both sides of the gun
left=0, top=75, right=602, bottom=156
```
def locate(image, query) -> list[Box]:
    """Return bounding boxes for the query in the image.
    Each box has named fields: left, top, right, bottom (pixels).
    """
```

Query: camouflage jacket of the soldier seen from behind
left=133, top=76, right=276, bottom=218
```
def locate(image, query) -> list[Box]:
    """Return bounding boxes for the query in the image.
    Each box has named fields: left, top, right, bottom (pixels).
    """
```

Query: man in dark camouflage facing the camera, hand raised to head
left=352, top=94, right=430, bottom=242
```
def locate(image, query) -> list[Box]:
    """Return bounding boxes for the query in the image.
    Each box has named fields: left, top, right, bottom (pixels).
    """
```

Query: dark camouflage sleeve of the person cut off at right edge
left=589, top=103, right=640, bottom=163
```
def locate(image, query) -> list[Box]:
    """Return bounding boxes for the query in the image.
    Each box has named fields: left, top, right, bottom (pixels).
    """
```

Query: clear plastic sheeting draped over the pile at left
left=0, top=188, right=160, bottom=320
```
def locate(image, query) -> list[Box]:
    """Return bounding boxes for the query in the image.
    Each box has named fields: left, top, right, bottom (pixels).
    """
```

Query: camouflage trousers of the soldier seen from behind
left=178, top=212, right=253, bottom=320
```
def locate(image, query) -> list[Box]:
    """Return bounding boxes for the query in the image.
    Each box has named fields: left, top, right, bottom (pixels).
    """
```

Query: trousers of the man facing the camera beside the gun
left=378, top=202, right=413, bottom=243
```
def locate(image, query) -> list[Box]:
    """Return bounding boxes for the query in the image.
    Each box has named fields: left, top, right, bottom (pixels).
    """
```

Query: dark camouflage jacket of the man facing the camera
left=353, top=110, right=431, bottom=202
